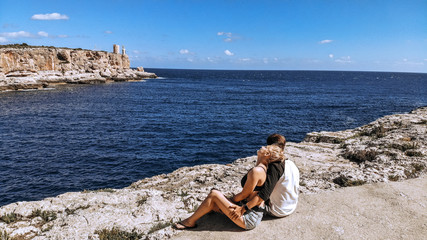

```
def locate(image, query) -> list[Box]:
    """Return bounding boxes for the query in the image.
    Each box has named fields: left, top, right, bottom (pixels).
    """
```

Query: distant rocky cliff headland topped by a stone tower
left=0, top=44, right=157, bottom=91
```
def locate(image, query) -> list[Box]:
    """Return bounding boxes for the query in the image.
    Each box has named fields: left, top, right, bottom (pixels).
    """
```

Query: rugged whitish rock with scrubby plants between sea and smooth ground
left=0, top=107, right=427, bottom=239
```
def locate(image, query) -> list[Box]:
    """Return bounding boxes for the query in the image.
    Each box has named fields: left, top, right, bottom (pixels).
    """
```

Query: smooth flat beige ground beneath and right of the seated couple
left=172, top=176, right=427, bottom=240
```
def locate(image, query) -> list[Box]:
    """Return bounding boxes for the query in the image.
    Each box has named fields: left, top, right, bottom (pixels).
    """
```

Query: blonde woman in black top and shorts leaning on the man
left=174, top=145, right=284, bottom=230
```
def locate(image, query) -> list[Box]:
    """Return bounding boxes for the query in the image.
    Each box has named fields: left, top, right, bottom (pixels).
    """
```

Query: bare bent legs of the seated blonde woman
left=182, top=190, right=245, bottom=228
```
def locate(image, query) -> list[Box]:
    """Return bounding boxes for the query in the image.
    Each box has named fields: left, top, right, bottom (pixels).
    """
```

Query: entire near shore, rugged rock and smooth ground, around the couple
left=0, top=107, right=427, bottom=239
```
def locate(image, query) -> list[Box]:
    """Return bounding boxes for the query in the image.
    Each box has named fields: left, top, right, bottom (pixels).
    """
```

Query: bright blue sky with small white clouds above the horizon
left=0, top=0, right=427, bottom=73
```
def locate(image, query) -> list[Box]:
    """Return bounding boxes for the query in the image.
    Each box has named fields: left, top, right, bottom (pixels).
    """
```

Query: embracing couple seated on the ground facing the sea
left=174, top=134, right=299, bottom=230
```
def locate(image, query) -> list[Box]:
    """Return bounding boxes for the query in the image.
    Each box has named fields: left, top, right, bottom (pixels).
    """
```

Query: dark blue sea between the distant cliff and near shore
left=0, top=69, right=427, bottom=206
